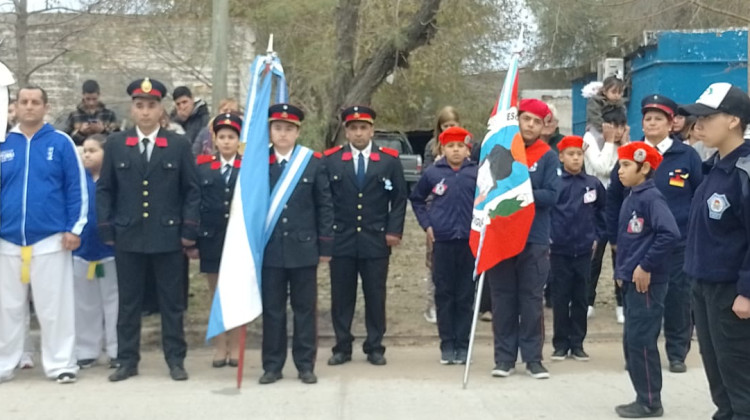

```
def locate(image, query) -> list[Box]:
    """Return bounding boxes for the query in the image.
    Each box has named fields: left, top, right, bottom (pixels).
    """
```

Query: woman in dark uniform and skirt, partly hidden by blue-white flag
left=191, top=113, right=242, bottom=368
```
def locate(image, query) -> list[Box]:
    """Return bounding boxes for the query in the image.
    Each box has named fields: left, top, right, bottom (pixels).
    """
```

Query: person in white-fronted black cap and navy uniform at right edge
left=683, top=83, right=750, bottom=420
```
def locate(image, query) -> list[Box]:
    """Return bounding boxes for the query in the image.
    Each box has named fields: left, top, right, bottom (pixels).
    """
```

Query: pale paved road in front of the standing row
left=0, top=340, right=713, bottom=420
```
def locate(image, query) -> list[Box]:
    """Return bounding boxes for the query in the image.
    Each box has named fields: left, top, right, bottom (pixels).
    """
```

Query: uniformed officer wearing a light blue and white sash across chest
left=259, top=104, right=333, bottom=384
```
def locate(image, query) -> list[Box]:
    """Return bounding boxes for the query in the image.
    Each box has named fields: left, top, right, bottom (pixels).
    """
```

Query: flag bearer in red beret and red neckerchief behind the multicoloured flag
left=486, top=99, right=560, bottom=379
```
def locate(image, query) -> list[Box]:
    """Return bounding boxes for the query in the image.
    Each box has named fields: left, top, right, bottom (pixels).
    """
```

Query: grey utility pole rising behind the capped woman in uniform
left=211, top=0, right=229, bottom=114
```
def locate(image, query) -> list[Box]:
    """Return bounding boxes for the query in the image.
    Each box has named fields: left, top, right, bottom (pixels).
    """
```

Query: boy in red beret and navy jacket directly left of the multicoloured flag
left=409, top=127, right=477, bottom=364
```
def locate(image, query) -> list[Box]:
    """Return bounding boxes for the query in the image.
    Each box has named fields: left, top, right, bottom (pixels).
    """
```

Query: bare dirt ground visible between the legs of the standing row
left=164, top=208, right=621, bottom=346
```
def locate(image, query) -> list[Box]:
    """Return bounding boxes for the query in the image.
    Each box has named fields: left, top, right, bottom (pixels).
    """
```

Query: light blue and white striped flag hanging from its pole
left=206, top=54, right=287, bottom=340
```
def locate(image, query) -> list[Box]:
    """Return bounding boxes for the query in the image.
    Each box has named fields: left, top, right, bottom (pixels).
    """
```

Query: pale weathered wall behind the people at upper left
left=0, top=14, right=256, bottom=126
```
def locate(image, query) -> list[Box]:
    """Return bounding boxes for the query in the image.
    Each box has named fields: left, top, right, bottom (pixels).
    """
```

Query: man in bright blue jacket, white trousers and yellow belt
left=0, top=87, right=88, bottom=383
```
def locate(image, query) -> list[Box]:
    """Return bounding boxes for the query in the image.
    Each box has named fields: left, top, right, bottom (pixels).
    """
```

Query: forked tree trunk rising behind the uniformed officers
left=325, top=0, right=441, bottom=147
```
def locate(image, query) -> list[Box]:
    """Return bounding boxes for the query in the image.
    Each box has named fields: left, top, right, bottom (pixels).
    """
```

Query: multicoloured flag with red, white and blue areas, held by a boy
left=469, top=49, right=534, bottom=274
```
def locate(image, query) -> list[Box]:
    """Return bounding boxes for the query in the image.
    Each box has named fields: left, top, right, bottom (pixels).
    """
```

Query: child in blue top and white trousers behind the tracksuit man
left=73, top=134, right=118, bottom=368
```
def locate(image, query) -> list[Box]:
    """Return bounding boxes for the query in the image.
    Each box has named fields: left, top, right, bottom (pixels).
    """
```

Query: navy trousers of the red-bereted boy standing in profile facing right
left=622, top=282, right=669, bottom=408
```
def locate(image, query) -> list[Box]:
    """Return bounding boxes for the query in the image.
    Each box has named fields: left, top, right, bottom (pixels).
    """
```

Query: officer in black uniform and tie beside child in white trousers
left=96, top=78, right=200, bottom=382
